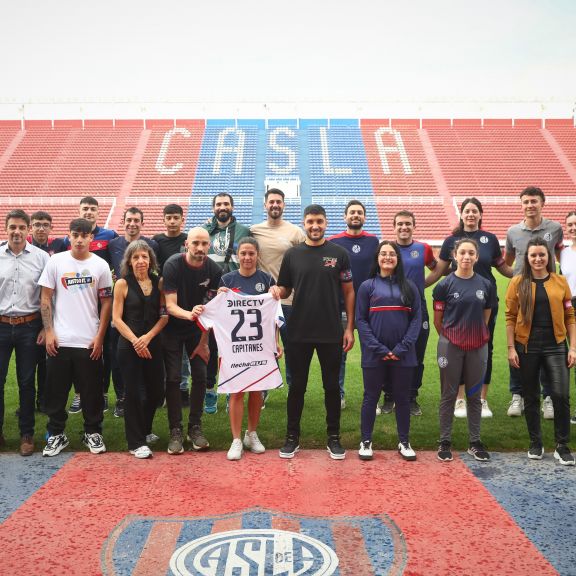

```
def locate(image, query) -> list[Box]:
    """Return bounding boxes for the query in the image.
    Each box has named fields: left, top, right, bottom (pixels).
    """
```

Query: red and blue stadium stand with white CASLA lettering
left=0, top=119, right=576, bottom=243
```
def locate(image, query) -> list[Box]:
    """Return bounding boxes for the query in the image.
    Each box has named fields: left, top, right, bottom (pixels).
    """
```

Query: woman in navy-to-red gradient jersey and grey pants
left=433, top=238, right=496, bottom=462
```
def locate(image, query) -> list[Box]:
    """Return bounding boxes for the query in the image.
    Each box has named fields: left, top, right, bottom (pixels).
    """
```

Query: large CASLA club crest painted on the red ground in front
left=101, top=508, right=408, bottom=576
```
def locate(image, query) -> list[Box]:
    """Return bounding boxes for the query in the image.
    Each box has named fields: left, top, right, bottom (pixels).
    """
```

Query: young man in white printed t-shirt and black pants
left=38, top=218, right=112, bottom=456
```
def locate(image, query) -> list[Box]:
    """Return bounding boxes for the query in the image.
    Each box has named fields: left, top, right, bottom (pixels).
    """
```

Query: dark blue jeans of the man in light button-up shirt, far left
left=0, top=318, right=42, bottom=436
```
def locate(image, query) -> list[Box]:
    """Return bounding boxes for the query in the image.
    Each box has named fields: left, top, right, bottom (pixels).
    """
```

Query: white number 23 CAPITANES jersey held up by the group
left=198, top=292, right=282, bottom=394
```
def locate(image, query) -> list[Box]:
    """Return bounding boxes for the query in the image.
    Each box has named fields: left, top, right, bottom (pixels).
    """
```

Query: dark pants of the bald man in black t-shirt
left=163, top=332, right=206, bottom=430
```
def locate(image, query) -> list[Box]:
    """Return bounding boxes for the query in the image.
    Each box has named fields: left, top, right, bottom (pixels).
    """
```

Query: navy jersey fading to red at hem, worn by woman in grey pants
left=432, top=273, right=496, bottom=350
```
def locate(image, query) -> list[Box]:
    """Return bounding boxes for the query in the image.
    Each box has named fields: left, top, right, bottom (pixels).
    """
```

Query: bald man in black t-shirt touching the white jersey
left=163, top=228, right=222, bottom=454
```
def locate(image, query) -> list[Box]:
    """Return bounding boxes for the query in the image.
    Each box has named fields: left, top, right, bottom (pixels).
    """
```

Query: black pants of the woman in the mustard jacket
left=516, top=328, right=570, bottom=444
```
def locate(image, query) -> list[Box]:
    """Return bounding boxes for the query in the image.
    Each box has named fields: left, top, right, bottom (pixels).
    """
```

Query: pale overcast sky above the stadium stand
left=0, top=0, right=576, bottom=102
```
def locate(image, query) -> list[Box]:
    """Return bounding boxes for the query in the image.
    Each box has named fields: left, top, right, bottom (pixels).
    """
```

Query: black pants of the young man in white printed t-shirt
left=45, top=346, right=104, bottom=436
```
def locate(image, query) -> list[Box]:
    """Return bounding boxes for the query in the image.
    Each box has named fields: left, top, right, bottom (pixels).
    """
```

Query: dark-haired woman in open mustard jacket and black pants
left=506, top=238, right=576, bottom=466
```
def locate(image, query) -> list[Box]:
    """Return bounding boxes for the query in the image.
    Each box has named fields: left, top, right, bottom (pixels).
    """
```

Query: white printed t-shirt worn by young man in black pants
left=38, top=252, right=112, bottom=348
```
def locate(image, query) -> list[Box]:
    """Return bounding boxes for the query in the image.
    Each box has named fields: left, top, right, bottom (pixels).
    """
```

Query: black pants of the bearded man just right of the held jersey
left=287, top=342, right=342, bottom=437
